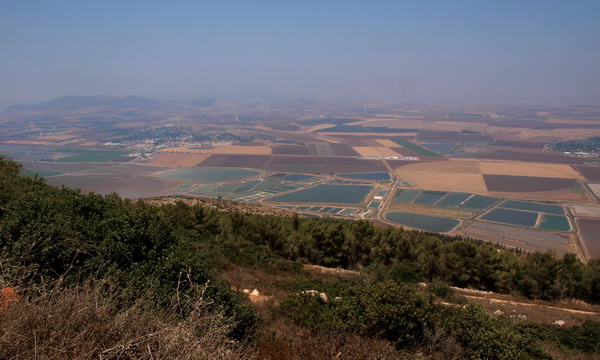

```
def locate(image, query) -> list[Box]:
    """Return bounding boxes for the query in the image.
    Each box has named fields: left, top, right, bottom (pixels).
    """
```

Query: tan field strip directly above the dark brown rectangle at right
left=479, top=161, right=584, bottom=180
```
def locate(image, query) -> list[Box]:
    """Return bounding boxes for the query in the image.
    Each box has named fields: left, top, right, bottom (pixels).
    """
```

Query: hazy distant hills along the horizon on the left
left=6, top=91, right=284, bottom=111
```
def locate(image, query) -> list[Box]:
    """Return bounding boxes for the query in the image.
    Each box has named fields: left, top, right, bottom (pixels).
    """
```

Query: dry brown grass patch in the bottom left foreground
left=0, top=284, right=251, bottom=360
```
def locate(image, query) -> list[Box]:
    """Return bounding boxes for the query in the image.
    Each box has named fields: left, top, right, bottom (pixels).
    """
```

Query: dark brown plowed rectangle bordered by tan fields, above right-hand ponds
left=483, top=174, right=576, bottom=192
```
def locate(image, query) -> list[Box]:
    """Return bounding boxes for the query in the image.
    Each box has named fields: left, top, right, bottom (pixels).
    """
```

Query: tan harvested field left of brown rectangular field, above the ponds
left=396, top=161, right=488, bottom=195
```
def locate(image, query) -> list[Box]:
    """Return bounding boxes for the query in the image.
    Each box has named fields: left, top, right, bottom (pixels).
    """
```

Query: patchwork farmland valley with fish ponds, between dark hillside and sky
left=0, top=96, right=600, bottom=261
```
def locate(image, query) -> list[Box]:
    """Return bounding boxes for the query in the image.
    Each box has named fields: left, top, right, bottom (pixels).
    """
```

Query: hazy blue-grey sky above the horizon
left=0, top=0, right=600, bottom=105
